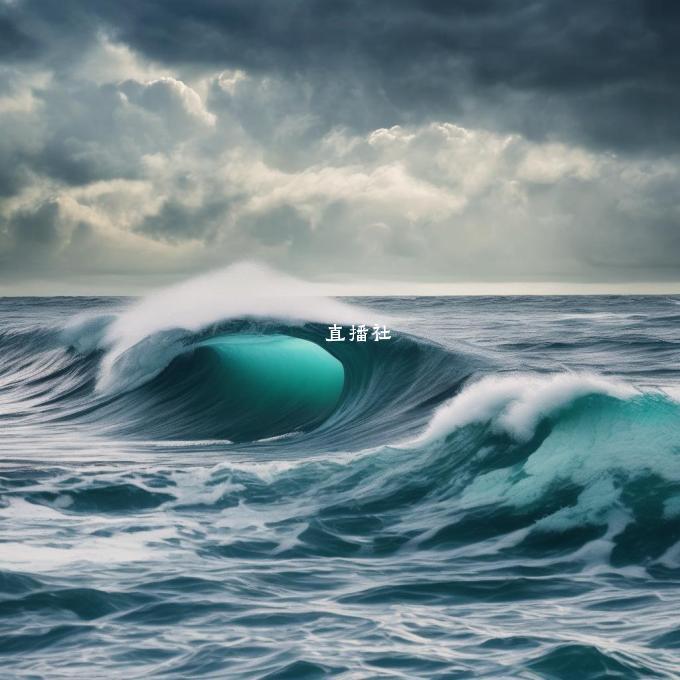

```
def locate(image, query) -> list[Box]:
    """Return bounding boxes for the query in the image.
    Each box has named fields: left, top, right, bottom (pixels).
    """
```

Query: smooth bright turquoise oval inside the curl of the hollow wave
left=196, top=335, right=345, bottom=441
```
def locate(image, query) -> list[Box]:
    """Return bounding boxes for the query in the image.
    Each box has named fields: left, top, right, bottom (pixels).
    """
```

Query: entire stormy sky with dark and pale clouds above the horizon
left=0, top=0, right=680, bottom=294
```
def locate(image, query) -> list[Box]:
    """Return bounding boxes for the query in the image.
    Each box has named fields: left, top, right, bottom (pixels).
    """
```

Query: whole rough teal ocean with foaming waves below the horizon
left=0, top=281, right=680, bottom=680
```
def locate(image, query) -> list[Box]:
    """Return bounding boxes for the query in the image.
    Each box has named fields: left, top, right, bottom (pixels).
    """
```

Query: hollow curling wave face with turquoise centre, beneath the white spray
left=27, top=319, right=472, bottom=446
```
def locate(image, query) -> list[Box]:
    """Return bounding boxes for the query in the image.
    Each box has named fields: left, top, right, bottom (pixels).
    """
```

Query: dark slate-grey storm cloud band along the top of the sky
left=5, top=0, right=680, bottom=150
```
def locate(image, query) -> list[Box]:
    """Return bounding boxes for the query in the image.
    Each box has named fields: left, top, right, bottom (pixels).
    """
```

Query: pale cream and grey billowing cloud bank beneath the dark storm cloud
left=0, top=36, right=680, bottom=288
